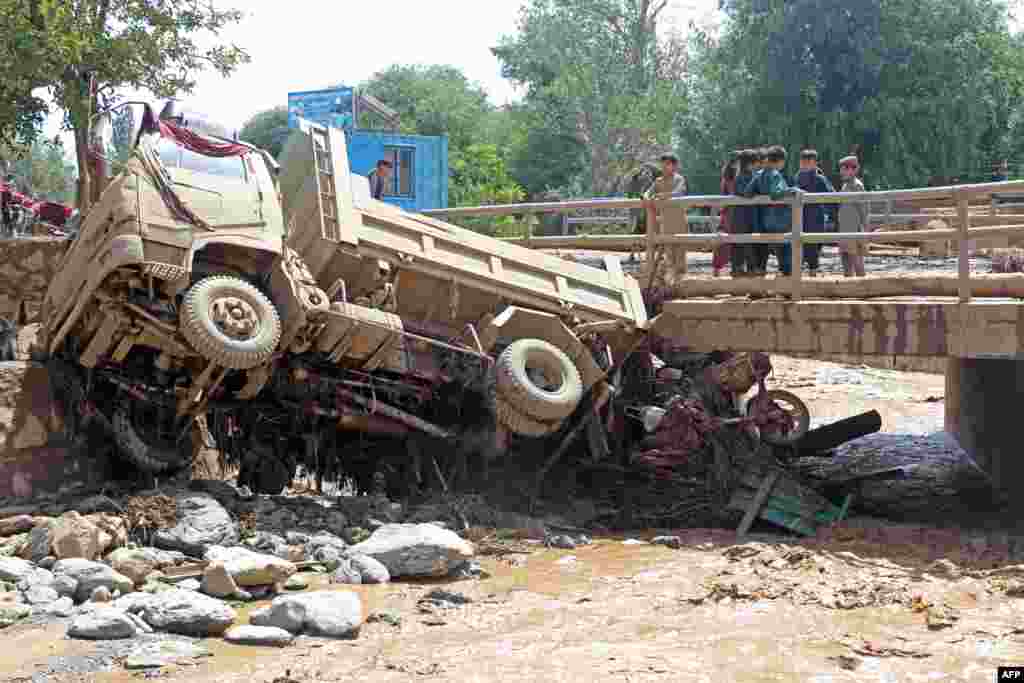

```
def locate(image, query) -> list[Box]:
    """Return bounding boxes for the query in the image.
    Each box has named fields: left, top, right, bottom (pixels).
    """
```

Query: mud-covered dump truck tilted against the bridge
left=43, top=103, right=646, bottom=493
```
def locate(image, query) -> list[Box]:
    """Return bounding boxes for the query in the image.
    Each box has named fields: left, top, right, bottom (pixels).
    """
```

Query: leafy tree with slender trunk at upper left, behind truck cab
left=0, top=0, right=248, bottom=210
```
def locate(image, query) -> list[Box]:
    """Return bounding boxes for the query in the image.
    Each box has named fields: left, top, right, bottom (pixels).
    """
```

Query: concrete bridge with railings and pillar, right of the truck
left=428, top=181, right=1024, bottom=488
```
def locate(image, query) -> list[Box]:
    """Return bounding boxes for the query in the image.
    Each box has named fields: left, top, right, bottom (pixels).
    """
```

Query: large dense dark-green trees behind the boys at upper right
left=679, top=0, right=1024, bottom=186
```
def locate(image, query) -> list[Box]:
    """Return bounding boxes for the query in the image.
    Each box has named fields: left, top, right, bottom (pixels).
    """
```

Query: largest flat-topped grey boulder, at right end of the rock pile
left=349, top=524, right=475, bottom=578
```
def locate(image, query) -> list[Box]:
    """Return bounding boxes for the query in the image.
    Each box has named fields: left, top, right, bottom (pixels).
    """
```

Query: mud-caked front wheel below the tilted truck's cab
left=180, top=275, right=281, bottom=370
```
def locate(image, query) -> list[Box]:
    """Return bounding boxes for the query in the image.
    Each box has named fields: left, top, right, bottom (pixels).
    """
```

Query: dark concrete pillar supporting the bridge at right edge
left=945, top=357, right=1024, bottom=488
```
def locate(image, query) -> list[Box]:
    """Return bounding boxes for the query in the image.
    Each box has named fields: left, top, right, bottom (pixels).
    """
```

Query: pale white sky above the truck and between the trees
left=46, top=0, right=718, bottom=148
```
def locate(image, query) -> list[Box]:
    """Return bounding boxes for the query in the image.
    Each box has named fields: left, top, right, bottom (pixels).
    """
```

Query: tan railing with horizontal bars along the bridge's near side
left=423, top=180, right=1024, bottom=302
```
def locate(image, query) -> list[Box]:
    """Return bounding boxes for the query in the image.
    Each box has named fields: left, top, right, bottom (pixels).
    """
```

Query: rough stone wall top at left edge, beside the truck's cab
left=0, top=238, right=70, bottom=322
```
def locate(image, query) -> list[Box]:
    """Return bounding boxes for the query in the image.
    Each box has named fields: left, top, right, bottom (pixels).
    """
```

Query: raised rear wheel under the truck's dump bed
left=497, top=339, right=583, bottom=422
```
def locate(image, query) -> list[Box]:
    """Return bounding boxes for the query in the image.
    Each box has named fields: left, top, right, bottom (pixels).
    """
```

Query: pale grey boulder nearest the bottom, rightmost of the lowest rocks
left=249, top=591, right=362, bottom=638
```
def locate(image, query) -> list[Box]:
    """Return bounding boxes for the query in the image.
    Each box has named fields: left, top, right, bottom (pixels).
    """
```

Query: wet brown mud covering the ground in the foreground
left=0, top=531, right=1024, bottom=683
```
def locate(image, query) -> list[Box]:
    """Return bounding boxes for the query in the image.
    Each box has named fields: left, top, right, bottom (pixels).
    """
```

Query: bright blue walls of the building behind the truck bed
left=288, top=87, right=449, bottom=211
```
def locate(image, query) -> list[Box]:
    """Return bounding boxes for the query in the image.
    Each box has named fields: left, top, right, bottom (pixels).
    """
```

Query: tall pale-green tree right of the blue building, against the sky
left=494, top=0, right=686, bottom=194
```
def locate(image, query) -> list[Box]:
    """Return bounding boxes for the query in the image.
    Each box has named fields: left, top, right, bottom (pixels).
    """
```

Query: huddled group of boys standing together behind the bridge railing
left=713, top=145, right=867, bottom=278
